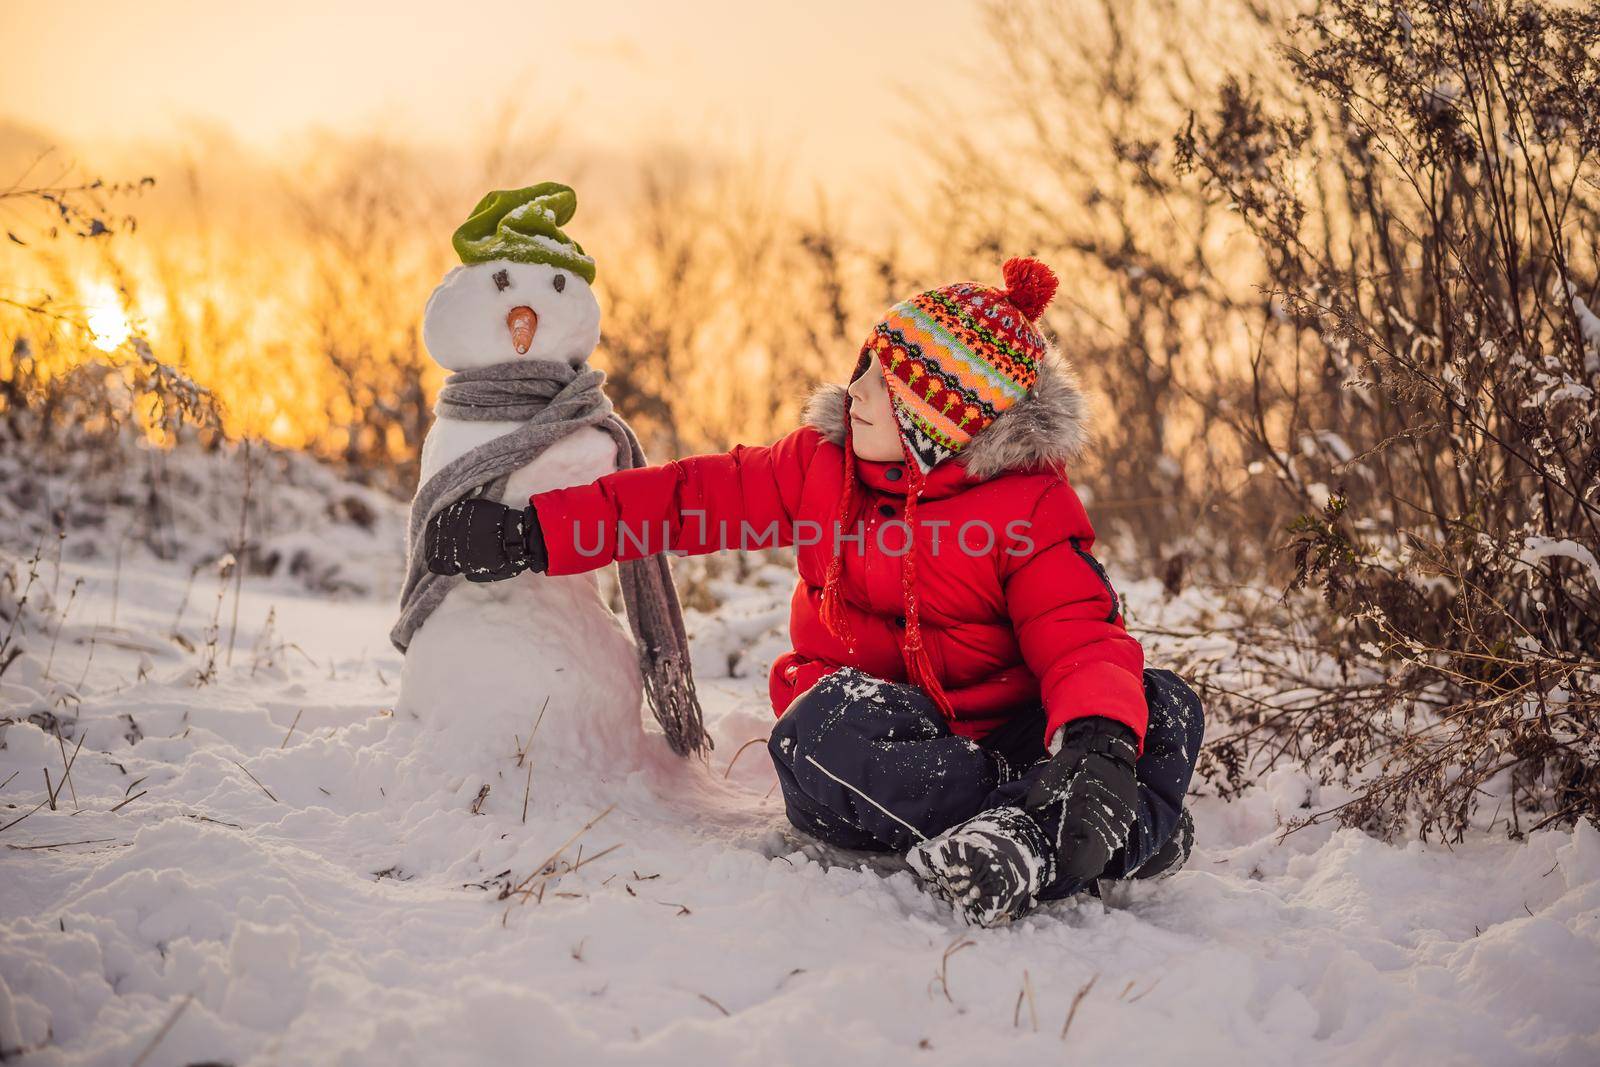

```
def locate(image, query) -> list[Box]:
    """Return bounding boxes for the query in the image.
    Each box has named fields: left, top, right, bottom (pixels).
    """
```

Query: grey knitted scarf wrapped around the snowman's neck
left=389, top=360, right=710, bottom=755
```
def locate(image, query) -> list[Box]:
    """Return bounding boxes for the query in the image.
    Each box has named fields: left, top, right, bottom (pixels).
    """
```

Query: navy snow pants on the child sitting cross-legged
left=766, top=667, right=1205, bottom=901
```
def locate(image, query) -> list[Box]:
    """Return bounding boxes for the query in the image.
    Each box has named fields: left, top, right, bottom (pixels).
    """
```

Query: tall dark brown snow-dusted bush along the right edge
left=1176, top=0, right=1600, bottom=833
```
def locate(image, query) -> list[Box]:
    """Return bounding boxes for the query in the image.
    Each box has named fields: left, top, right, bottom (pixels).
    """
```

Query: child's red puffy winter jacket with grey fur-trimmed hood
left=531, top=360, right=1147, bottom=745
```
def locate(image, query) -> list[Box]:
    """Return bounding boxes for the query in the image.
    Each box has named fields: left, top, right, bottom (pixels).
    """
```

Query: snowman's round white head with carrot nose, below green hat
left=422, top=259, right=600, bottom=371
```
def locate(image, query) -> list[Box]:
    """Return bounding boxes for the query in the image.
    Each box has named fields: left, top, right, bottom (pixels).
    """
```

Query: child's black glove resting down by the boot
left=1022, top=715, right=1139, bottom=885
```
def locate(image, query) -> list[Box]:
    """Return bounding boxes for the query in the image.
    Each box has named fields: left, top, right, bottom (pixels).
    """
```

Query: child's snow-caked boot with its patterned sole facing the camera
left=906, top=806, right=1054, bottom=926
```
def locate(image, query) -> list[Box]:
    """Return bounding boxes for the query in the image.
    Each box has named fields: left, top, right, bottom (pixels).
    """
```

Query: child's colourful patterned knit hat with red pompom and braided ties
left=821, top=259, right=1058, bottom=715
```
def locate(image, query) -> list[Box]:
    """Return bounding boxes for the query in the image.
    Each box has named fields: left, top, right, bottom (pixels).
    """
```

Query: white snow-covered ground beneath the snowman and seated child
left=0, top=495, right=1600, bottom=1067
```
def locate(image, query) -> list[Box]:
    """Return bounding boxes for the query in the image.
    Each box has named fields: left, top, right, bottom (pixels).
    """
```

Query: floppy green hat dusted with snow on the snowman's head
left=450, top=181, right=595, bottom=285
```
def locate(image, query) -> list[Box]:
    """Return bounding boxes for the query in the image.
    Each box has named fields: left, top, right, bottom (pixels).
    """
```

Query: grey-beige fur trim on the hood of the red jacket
left=803, top=352, right=1090, bottom=480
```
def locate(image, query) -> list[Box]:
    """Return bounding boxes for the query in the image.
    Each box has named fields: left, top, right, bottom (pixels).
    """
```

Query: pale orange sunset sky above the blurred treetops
left=0, top=0, right=981, bottom=214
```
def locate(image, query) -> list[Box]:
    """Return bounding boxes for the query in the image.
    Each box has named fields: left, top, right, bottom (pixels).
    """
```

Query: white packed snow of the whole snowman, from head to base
left=397, top=261, right=643, bottom=783
